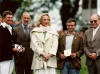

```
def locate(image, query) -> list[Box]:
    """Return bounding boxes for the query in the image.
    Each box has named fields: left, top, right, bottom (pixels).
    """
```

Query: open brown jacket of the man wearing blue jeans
left=57, top=31, right=83, bottom=69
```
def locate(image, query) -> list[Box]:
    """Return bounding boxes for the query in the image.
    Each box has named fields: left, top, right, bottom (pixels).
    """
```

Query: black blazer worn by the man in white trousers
left=0, top=25, right=15, bottom=62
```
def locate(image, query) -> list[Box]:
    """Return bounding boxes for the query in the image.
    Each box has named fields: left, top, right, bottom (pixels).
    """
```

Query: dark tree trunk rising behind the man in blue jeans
left=60, top=0, right=80, bottom=30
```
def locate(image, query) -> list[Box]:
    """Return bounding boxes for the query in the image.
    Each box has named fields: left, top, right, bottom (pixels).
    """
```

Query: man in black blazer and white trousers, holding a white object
left=0, top=10, right=18, bottom=74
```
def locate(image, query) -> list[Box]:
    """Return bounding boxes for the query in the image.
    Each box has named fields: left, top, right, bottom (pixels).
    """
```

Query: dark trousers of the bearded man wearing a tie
left=15, top=50, right=33, bottom=74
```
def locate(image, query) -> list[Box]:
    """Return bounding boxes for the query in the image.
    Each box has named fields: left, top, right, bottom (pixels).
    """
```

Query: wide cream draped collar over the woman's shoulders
left=31, top=26, right=58, bottom=43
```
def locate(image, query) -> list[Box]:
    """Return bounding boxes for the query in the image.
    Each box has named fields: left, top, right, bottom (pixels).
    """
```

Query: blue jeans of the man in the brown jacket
left=61, top=60, right=80, bottom=74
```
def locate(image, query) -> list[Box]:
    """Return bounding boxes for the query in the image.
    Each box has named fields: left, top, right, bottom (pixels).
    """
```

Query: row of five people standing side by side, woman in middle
left=0, top=10, right=100, bottom=74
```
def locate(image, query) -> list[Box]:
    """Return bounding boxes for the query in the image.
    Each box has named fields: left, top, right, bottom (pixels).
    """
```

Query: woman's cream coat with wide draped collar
left=31, top=26, right=58, bottom=70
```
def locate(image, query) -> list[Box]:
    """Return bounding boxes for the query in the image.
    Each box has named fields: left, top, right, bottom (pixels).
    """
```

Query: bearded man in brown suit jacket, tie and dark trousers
left=15, top=12, right=33, bottom=74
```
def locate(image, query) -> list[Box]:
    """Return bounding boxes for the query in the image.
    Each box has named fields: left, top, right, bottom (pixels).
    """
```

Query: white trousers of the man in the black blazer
left=0, top=60, right=14, bottom=74
